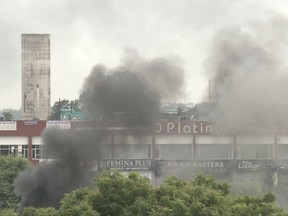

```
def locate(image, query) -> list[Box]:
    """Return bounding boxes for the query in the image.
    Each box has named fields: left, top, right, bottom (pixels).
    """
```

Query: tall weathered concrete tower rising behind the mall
left=21, top=34, right=50, bottom=120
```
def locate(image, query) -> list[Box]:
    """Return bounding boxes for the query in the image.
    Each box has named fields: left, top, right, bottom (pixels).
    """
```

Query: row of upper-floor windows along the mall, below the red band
left=0, top=144, right=288, bottom=160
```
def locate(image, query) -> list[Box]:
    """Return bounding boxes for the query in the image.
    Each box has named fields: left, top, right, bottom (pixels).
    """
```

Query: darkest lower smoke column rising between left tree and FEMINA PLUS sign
left=15, top=128, right=106, bottom=211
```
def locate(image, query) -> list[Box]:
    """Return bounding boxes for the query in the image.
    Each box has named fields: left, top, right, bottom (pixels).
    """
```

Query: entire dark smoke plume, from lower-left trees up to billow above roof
left=15, top=52, right=184, bottom=212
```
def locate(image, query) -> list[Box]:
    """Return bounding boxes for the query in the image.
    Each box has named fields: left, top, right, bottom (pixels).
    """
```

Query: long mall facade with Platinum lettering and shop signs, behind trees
left=0, top=121, right=288, bottom=184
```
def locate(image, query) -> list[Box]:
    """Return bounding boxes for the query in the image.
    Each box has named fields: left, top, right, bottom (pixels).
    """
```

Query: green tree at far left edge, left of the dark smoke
left=0, top=156, right=29, bottom=209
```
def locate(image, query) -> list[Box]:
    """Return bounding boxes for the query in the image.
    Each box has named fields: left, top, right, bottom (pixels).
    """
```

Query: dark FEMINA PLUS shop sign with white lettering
left=102, top=159, right=152, bottom=171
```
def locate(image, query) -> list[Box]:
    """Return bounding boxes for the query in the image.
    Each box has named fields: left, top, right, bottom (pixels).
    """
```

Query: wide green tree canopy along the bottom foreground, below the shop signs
left=17, top=172, right=288, bottom=216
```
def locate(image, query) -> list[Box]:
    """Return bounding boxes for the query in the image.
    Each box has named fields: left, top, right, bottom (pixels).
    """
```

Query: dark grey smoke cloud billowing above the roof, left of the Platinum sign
left=80, top=50, right=184, bottom=127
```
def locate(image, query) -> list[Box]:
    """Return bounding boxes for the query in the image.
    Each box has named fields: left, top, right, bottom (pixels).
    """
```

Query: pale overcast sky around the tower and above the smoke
left=0, top=0, right=288, bottom=109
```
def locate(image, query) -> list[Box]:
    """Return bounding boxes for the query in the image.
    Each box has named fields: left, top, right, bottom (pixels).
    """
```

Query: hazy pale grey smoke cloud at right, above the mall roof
left=207, top=15, right=288, bottom=129
